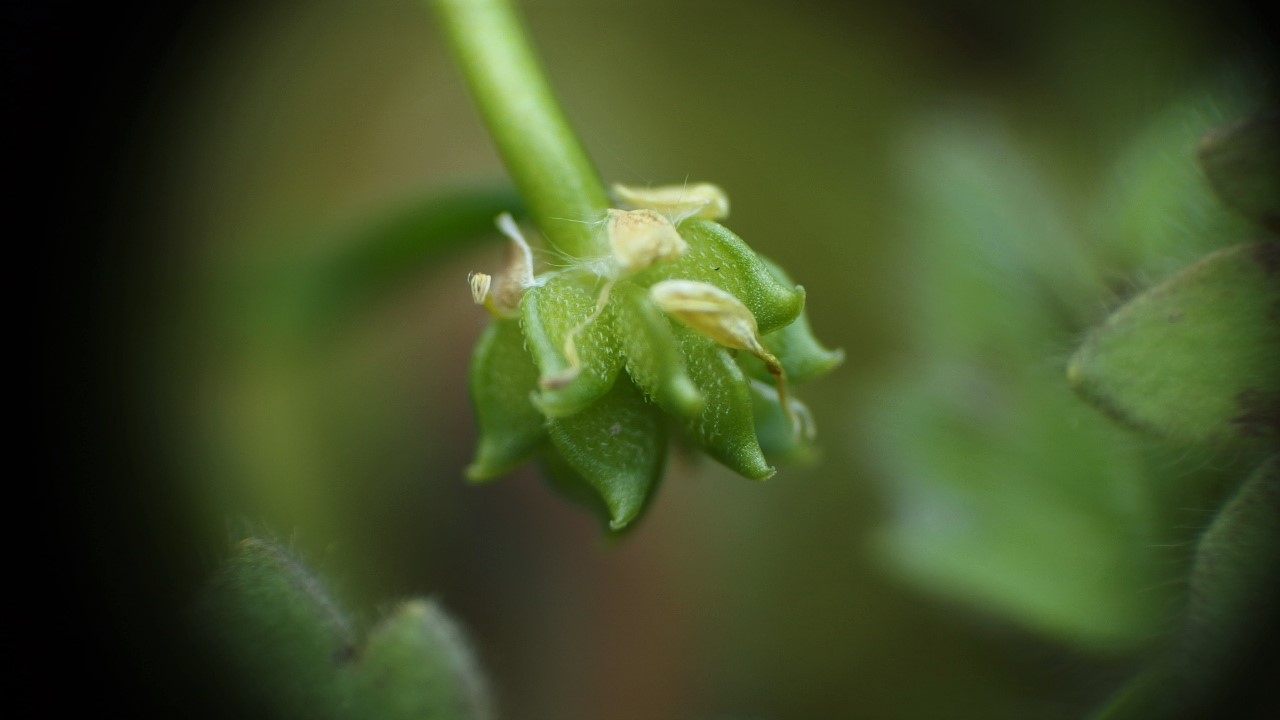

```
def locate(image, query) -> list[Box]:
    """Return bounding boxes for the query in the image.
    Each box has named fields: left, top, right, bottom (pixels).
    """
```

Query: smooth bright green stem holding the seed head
left=430, top=0, right=609, bottom=258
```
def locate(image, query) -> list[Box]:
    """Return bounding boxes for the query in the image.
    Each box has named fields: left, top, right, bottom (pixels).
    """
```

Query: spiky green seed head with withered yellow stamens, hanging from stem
left=467, top=184, right=844, bottom=530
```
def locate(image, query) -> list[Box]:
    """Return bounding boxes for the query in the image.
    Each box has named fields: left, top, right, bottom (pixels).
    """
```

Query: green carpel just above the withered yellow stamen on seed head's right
left=636, top=218, right=804, bottom=333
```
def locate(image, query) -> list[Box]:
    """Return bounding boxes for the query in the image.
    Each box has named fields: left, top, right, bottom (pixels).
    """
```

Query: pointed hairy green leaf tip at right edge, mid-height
left=1068, top=242, right=1280, bottom=442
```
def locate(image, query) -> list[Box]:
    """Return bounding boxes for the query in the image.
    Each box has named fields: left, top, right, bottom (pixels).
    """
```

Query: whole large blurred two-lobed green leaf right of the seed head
left=863, top=115, right=1170, bottom=651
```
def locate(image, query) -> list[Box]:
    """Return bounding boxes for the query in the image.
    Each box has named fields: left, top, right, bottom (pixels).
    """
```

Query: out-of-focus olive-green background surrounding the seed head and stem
left=85, top=0, right=1266, bottom=720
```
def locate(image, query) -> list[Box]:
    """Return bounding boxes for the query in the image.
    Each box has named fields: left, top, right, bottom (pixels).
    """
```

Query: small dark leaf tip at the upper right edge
left=1198, top=108, right=1280, bottom=233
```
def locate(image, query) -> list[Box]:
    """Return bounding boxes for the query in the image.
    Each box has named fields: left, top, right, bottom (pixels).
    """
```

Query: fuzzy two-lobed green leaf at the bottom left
left=193, top=538, right=493, bottom=720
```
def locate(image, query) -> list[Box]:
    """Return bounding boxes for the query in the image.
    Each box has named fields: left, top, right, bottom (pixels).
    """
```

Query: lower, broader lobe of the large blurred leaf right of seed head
left=868, top=363, right=1169, bottom=651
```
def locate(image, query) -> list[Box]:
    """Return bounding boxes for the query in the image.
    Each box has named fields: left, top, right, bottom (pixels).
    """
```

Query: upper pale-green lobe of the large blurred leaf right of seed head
left=900, top=113, right=1105, bottom=345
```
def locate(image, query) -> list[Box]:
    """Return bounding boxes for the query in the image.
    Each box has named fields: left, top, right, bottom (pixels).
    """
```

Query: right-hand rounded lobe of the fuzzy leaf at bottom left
left=346, top=598, right=493, bottom=720
